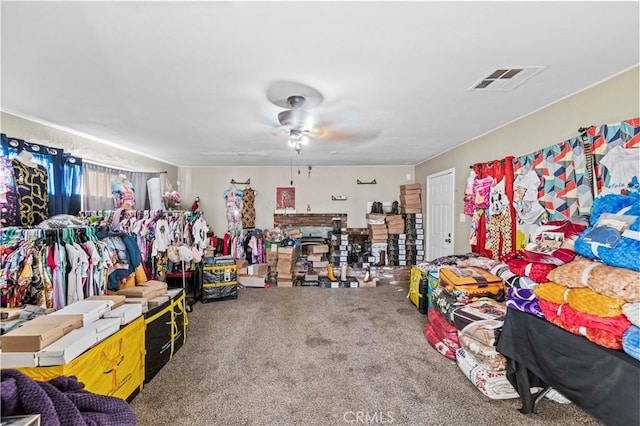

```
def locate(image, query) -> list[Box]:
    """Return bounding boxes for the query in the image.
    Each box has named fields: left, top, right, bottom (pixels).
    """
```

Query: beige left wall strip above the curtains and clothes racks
left=0, top=112, right=178, bottom=181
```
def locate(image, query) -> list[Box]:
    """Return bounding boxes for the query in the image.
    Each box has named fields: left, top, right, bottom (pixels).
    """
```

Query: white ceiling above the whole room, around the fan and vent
left=1, top=1, right=640, bottom=166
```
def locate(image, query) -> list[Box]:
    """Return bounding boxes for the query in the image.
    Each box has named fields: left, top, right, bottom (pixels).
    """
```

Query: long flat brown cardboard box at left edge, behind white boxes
left=0, top=315, right=82, bottom=352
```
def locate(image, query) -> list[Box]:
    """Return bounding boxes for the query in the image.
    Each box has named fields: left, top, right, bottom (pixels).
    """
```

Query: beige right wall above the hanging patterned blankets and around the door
left=415, top=67, right=640, bottom=253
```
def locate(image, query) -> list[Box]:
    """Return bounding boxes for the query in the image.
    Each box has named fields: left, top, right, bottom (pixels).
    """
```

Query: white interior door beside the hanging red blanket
left=424, top=169, right=455, bottom=261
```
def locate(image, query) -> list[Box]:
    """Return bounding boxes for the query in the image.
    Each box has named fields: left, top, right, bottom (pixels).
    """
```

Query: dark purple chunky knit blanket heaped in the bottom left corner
left=0, top=369, right=136, bottom=426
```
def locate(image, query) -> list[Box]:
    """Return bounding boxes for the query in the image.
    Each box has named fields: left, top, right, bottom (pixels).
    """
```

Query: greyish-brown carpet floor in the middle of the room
left=131, top=285, right=602, bottom=426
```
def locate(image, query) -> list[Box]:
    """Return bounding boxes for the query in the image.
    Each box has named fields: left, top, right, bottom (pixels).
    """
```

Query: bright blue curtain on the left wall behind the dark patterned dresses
left=1, top=133, right=82, bottom=217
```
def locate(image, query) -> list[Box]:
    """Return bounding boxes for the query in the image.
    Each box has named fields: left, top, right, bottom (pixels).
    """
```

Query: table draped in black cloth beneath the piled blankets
left=497, top=309, right=640, bottom=426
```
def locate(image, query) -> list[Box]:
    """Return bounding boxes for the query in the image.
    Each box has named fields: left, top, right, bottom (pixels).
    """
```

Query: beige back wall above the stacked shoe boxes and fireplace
left=179, top=166, right=413, bottom=235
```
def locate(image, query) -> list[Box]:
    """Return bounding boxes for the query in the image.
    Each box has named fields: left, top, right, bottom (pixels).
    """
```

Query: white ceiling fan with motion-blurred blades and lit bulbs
left=267, top=81, right=382, bottom=154
